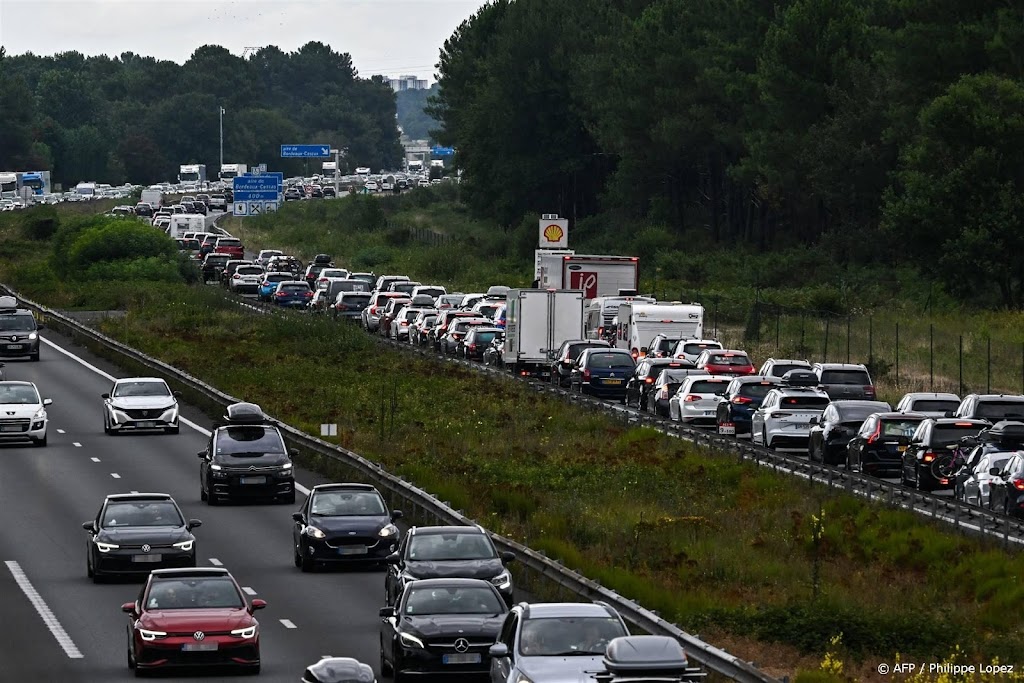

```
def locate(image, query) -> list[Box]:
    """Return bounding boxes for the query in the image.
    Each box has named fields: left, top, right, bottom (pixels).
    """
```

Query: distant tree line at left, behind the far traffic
left=0, top=42, right=402, bottom=187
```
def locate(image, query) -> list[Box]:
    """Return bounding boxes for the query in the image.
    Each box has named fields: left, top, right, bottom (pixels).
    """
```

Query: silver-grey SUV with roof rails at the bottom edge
left=489, top=602, right=630, bottom=683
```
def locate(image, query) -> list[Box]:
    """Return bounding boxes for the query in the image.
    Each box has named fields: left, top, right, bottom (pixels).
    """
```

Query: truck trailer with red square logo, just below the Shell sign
left=537, top=250, right=640, bottom=300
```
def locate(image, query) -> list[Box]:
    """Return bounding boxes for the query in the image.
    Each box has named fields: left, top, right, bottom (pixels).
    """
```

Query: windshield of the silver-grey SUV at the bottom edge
left=519, top=616, right=628, bottom=657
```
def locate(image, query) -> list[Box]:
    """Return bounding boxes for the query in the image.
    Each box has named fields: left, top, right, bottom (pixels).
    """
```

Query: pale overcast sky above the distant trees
left=0, top=0, right=484, bottom=82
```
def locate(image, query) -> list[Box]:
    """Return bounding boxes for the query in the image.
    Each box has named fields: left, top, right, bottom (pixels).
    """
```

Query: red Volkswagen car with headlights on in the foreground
left=121, top=567, right=266, bottom=675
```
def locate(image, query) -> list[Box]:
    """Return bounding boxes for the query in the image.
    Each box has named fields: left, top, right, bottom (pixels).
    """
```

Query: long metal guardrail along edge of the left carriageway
left=0, top=285, right=778, bottom=683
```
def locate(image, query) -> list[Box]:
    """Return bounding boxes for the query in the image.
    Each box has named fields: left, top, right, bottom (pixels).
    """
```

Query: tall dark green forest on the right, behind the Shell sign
left=430, top=0, right=1024, bottom=308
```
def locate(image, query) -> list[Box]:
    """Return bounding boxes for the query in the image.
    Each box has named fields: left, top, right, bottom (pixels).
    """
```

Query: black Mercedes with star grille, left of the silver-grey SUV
left=380, top=579, right=508, bottom=683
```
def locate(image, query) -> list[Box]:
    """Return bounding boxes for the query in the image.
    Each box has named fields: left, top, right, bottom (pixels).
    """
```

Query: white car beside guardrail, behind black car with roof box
left=102, top=377, right=178, bottom=434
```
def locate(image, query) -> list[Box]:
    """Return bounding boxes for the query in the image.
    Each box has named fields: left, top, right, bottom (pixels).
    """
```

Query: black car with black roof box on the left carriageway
left=198, top=403, right=298, bottom=505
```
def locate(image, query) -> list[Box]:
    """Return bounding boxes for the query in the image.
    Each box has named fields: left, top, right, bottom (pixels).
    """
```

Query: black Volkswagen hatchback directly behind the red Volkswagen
left=82, top=494, right=203, bottom=584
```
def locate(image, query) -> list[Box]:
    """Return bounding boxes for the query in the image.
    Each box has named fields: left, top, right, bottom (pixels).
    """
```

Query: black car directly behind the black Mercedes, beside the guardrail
left=384, top=526, right=515, bottom=605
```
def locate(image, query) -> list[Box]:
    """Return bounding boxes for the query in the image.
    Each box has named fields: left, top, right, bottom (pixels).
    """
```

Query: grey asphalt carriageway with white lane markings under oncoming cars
left=0, top=331, right=384, bottom=683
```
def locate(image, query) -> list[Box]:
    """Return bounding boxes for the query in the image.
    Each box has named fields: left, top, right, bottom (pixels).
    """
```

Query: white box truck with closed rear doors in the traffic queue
left=502, top=289, right=584, bottom=376
